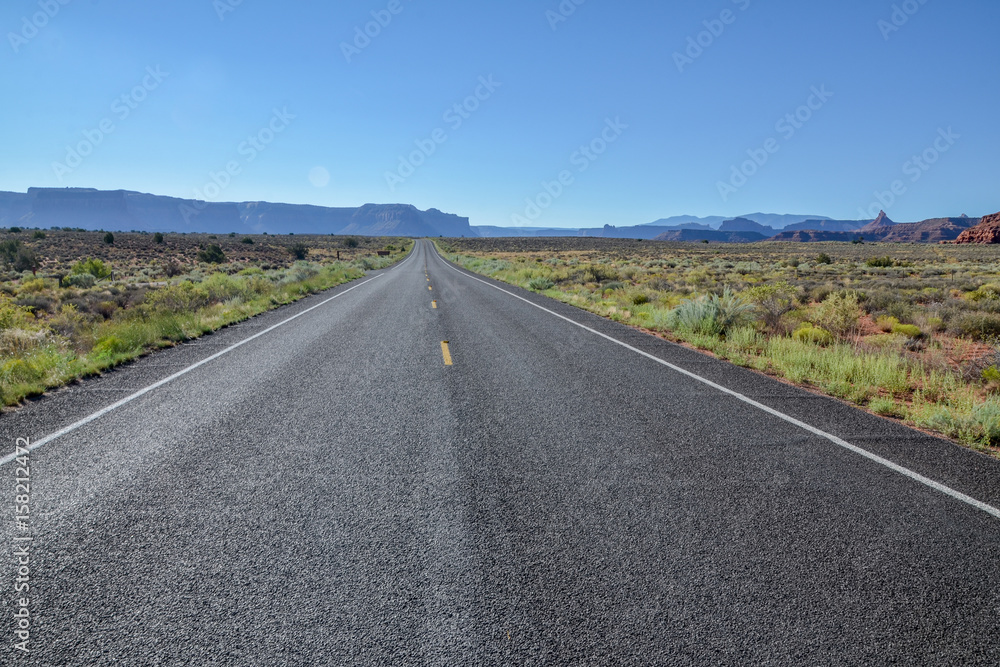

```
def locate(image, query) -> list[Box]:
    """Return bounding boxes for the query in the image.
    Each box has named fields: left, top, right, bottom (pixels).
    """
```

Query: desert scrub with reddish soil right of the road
left=439, top=238, right=1000, bottom=455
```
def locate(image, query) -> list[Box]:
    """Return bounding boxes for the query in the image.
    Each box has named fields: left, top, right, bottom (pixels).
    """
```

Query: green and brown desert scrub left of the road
left=0, top=228, right=412, bottom=406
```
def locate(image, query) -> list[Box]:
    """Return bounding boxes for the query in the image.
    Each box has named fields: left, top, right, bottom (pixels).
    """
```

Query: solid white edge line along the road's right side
left=438, top=245, right=1000, bottom=519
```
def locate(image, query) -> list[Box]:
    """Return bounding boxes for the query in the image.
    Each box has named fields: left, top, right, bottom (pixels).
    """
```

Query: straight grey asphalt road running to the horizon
left=0, top=241, right=1000, bottom=665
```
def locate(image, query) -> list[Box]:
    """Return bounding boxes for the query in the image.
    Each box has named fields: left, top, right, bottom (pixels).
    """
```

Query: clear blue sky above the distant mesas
left=0, top=0, right=1000, bottom=227
